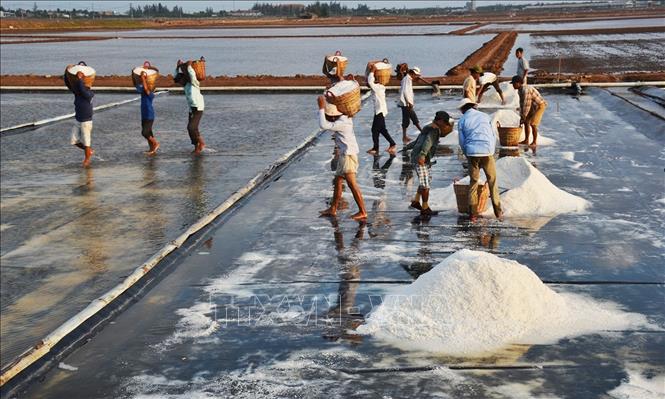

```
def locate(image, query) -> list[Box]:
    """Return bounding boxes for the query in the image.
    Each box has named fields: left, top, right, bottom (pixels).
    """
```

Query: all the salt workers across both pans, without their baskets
left=64, top=48, right=547, bottom=222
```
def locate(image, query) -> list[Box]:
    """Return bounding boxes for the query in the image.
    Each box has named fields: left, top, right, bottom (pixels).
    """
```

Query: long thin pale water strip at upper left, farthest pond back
left=2, top=25, right=468, bottom=38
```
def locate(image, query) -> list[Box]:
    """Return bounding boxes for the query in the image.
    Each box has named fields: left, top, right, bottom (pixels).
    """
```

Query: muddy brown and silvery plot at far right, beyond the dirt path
left=530, top=33, right=665, bottom=73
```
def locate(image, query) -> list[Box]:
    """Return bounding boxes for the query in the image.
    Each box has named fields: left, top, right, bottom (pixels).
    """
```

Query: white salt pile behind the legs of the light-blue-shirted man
left=429, top=157, right=590, bottom=216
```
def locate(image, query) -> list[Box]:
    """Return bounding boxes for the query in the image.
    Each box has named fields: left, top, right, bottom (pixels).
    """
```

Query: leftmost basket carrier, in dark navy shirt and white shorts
left=63, top=65, right=95, bottom=168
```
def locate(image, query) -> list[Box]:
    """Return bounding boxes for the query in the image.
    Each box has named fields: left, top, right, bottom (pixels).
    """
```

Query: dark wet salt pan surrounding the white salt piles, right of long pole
left=26, top=89, right=665, bottom=398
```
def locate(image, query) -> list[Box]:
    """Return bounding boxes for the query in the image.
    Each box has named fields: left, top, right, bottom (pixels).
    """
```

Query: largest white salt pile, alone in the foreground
left=358, top=249, right=654, bottom=356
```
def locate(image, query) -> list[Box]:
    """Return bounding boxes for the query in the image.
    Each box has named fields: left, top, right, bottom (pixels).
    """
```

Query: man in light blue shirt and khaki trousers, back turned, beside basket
left=457, top=98, right=503, bottom=222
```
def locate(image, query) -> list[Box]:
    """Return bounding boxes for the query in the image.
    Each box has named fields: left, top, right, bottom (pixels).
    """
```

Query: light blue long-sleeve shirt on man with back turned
left=457, top=108, right=496, bottom=157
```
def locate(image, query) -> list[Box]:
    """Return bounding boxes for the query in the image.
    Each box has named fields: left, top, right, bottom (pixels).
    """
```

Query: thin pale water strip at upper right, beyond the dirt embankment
left=474, top=17, right=665, bottom=33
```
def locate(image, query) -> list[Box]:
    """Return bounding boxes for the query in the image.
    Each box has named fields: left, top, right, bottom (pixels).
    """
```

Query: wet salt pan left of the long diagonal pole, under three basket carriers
left=0, top=94, right=315, bottom=365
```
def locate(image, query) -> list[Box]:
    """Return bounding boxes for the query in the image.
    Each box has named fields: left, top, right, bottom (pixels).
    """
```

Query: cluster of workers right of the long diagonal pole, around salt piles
left=317, top=48, right=547, bottom=223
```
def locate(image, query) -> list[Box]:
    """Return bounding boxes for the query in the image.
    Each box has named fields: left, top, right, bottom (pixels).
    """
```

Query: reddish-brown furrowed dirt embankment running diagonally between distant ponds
left=446, top=32, right=517, bottom=77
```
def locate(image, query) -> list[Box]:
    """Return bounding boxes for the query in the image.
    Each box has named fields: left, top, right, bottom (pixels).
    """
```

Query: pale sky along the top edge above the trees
left=0, top=0, right=538, bottom=13
